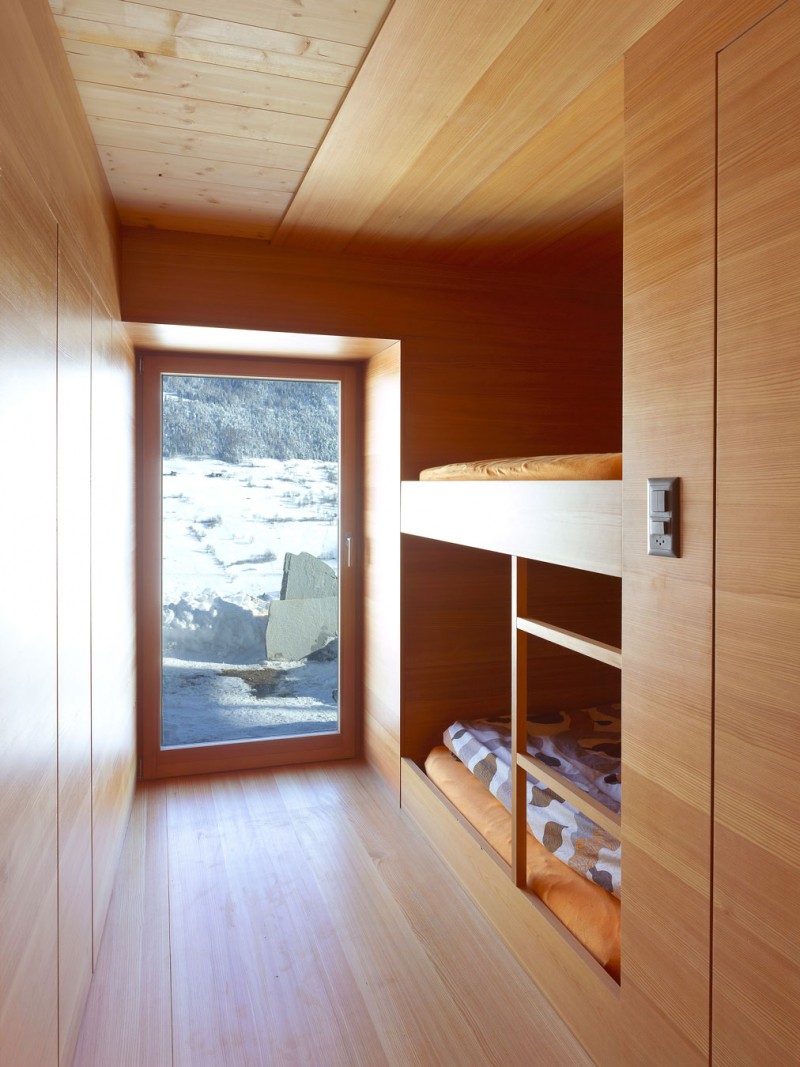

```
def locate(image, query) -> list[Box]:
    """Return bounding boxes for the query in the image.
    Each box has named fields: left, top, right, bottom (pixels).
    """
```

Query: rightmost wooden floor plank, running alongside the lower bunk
left=278, top=765, right=589, bottom=1067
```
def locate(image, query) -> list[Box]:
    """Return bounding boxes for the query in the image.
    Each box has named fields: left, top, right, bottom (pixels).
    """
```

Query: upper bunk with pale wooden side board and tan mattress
left=400, top=452, right=622, bottom=576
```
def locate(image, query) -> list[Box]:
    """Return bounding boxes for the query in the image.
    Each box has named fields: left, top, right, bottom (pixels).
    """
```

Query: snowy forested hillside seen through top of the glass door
left=163, top=375, right=339, bottom=463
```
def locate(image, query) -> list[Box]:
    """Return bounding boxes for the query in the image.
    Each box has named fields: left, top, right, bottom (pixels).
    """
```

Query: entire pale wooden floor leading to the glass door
left=75, top=762, right=591, bottom=1067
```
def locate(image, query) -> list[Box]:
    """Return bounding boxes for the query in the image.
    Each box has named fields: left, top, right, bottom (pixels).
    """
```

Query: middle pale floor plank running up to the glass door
left=170, top=773, right=385, bottom=1067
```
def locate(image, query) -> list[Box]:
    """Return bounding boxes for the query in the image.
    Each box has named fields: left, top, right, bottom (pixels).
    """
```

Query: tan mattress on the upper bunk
left=419, top=452, right=622, bottom=481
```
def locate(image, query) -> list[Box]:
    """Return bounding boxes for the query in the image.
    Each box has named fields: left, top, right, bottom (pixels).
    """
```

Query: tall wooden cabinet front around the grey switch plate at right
left=622, top=0, right=800, bottom=1065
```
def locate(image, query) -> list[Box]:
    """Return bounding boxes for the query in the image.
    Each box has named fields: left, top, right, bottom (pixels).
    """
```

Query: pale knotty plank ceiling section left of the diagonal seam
left=50, top=0, right=386, bottom=238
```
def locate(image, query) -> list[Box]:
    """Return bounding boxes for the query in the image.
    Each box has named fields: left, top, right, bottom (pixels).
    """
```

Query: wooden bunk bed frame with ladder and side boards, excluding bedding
left=401, top=481, right=622, bottom=1062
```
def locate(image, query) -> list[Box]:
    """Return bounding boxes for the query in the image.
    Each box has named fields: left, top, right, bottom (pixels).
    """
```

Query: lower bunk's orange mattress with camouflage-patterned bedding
left=425, top=704, right=622, bottom=982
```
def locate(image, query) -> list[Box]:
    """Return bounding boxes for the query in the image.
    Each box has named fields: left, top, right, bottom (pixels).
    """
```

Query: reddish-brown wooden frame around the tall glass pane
left=137, top=351, right=362, bottom=779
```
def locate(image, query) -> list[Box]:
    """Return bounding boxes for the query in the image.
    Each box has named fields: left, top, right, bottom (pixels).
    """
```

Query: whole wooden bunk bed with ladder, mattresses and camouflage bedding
left=401, top=453, right=622, bottom=982
